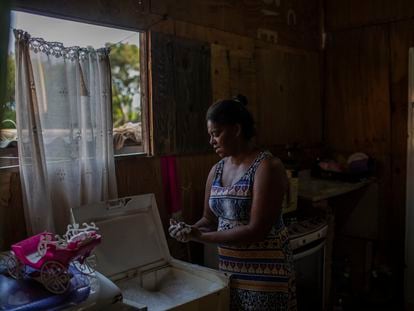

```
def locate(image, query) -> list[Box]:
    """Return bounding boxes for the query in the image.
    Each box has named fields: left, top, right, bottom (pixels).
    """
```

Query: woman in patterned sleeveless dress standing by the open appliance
left=169, top=95, right=296, bottom=311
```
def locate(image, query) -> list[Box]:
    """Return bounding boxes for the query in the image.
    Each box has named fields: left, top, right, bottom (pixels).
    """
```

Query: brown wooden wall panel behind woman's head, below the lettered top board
left=153, top=17, right=322, bottom=146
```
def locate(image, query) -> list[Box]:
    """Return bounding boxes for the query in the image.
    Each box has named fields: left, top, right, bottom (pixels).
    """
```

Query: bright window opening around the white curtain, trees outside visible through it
left=0, top=11, right=144, bottom=168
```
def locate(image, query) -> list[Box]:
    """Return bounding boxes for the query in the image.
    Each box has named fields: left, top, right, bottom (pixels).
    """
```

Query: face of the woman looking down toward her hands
left=207, top=120, right=240, bottom=158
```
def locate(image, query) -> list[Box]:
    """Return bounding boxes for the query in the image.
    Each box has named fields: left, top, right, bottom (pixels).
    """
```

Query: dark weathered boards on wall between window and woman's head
left=150, top=32, right=211, bottom=155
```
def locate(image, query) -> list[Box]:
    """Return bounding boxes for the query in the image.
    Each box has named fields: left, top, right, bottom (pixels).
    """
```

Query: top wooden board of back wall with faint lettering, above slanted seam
left=151, top=0, right=320, bottom=49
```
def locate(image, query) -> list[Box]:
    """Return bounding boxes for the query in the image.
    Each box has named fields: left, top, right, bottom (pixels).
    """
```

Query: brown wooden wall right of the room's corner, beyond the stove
left=324, top=0, right=414, bottom=296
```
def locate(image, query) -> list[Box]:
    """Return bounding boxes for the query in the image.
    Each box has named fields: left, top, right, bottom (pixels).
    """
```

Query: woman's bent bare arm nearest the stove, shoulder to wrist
left=190, top=158, right=288, bottom=244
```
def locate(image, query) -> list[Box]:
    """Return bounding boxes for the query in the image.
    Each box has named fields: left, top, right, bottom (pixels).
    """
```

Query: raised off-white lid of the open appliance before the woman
left=72, top=193, right=171, bottom=280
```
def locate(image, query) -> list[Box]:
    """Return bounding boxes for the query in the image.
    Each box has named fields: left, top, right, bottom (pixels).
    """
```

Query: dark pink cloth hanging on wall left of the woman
left=161, top=156, right=181, bottom=214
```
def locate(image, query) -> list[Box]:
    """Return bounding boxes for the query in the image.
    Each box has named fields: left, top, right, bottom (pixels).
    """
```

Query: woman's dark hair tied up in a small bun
left=206, top=95, right=256, bottom=140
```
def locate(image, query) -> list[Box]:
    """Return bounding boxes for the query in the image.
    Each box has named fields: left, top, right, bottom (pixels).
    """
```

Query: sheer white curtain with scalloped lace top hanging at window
left=15, top=30, right=117, bottom=234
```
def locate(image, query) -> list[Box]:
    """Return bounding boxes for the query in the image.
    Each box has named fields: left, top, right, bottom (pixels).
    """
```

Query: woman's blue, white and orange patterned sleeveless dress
left=209, top=151, right=296, bottom=311
